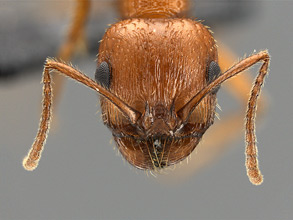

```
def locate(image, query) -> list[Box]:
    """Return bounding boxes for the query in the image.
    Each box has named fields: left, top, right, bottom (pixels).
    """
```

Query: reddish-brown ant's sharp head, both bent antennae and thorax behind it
left=23, top=0, right=270, bottom=185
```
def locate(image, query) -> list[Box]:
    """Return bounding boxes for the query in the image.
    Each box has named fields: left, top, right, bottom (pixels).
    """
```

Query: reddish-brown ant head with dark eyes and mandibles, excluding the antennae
left=96, top=19, right=220, bottom=169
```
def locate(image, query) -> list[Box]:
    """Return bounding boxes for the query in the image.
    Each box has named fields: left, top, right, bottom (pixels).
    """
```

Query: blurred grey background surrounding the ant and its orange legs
left=0, top=0, right=293, bottom=220
